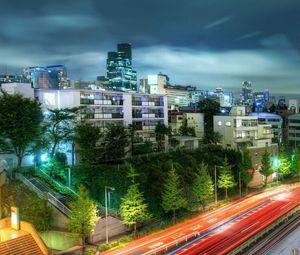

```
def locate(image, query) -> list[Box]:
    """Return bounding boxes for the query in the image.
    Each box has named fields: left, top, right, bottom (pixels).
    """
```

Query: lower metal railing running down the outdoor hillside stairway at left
left=16, top=173, right=71, bottom=217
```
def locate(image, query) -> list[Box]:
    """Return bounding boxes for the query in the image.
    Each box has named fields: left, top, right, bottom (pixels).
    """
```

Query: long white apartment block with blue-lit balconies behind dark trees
left=2, top=83, right=168, bottom=142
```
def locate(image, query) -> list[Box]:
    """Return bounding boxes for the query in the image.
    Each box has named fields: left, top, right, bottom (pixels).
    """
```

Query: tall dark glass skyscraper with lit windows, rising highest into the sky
left=106, top=43, right=137, bottom=91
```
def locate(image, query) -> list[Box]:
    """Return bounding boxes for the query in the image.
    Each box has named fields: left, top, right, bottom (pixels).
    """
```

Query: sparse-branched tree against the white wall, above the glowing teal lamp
left=45, top=108, right=79, bottom=158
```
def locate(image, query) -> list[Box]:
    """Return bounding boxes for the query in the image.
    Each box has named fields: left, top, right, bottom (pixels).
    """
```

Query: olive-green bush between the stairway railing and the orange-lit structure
left=1, top=182, right=52, bottom=231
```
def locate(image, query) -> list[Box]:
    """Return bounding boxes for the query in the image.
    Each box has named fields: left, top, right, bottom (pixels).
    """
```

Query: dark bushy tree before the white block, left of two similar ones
left=75, top=123, right=104, bottom=165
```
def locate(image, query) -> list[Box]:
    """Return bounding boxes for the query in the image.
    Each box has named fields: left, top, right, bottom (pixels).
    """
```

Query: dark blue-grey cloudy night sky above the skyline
left=0, top=0, right=300, bottom=93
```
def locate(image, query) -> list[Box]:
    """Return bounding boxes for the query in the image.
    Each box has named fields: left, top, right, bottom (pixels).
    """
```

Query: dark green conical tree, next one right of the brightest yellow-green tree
left=162, top=165, right=187, bottom=223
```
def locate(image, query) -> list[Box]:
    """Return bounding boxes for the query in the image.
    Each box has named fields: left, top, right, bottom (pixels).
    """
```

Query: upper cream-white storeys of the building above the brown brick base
left=214, top=107, right=274, bottom=149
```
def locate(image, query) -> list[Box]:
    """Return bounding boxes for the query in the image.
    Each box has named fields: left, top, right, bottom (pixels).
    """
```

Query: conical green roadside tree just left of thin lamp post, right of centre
left=193, top=163, right=214, bottom=210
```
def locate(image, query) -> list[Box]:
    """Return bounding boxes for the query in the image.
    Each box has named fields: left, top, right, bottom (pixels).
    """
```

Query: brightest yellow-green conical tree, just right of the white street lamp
left=120, top=168, right=151, bottom=236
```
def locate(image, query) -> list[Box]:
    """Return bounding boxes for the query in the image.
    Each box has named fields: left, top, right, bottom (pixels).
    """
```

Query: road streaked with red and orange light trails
left=104, top=186, right=300, bottom=255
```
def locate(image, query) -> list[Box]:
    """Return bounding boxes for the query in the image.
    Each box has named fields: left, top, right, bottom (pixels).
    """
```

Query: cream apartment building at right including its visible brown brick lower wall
left=214, top=107, right=278, bottom=187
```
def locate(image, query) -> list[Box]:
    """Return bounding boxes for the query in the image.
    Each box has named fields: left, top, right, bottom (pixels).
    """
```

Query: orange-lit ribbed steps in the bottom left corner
left=0, top=234, right=43, bottom=255
